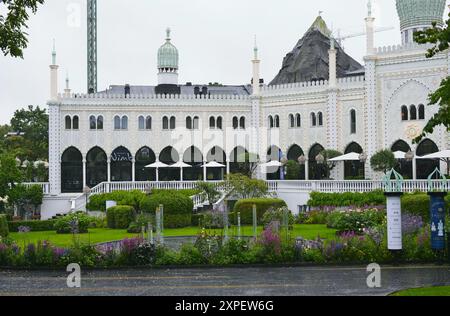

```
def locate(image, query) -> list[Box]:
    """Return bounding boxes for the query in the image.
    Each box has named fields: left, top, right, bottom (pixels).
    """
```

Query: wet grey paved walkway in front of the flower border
left=0, top=266, right=450, bottom=296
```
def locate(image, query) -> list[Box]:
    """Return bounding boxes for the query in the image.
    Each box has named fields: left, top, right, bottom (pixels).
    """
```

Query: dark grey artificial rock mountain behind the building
left=270, top=16, right=364, bottom=85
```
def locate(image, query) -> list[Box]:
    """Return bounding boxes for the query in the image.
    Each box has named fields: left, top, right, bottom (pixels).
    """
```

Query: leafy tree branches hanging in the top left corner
left=0, top=0, right=44, bottom=58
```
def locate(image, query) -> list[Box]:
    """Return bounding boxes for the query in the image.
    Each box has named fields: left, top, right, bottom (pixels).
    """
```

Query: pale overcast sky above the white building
left=0, top=0, right=442, bottom=124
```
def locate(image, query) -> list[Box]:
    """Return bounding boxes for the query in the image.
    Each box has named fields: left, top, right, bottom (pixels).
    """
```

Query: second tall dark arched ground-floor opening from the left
left=86, top=147, right=108, bottom=188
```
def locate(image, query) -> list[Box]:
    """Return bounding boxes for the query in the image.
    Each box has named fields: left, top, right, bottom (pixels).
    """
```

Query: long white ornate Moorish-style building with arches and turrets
left=44, top=0, right=450, bottom=215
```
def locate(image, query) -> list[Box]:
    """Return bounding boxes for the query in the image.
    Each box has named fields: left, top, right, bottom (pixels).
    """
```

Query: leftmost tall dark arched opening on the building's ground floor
left=61, top=147, right=83, bottom=193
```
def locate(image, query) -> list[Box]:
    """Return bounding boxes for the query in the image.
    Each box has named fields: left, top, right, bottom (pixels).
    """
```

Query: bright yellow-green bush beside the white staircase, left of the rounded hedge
left=86, top=190, right=146, bottom=212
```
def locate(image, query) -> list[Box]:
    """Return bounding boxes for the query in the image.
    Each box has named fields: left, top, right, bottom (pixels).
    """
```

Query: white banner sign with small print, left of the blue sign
left=386, top=195, right=403, bottom=250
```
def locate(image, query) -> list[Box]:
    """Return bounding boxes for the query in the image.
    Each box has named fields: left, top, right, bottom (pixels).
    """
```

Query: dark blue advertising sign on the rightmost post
left=429, top=193, right=446, bottom=250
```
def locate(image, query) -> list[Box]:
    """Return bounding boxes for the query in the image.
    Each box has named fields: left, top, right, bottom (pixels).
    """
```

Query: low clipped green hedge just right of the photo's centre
left=229, top=198, right=287, bottom=225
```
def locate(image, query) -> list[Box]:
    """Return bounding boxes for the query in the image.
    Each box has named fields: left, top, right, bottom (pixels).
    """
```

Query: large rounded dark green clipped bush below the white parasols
left=140, top=191, right=194, bottom=228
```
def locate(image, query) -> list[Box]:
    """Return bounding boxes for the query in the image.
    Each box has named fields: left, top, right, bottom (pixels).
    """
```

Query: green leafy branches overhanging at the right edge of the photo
left=414, top=15, right=450, bottom=143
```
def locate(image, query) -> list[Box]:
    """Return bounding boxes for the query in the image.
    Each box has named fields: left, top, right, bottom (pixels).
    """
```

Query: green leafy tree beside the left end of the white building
left=6, top=105, right=48, bottom=161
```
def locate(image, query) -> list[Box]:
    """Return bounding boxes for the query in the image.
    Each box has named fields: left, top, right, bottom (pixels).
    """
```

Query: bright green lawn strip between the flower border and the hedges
left=10, top=225, right=336, bottom=247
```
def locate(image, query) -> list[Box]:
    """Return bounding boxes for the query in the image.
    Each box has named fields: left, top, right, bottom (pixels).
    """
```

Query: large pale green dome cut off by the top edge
left=397, top=0, right=445, bottom=30
